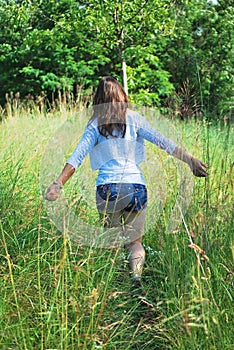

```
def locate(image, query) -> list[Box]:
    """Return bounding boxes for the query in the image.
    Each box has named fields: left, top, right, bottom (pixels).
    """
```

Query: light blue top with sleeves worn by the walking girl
left=67, top=110, right=177, bottom=186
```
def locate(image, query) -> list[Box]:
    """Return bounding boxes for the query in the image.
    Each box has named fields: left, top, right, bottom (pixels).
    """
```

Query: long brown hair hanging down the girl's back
left=91, top=76, right=128, bottom=138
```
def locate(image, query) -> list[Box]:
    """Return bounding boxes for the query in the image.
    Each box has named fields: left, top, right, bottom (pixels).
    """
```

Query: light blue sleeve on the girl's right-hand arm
left=138, top=116, right=177, bottom=154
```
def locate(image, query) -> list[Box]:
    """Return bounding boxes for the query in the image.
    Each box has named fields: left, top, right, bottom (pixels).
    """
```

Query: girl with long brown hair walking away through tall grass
left=45, top=76, right=208, bottom=287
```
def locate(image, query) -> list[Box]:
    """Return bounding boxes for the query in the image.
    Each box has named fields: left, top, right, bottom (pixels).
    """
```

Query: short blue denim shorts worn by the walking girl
left=96, top=183, right=147, bottom=213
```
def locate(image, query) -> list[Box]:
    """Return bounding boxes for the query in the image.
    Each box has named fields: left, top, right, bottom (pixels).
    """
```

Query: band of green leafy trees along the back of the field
left=0, top=0, right=234, bottom=119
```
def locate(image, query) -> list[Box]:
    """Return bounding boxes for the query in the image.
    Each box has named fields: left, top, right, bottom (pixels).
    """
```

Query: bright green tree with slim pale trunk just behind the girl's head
left=78, top=0, right=174, bottom=105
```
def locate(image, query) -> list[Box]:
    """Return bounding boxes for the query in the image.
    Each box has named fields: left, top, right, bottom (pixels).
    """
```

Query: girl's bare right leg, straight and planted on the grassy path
left=124, top=209, right=146, bottom=279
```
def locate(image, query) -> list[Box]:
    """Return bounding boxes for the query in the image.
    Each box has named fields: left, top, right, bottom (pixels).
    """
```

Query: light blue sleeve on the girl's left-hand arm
left=67, top=125, right=97, bottom=169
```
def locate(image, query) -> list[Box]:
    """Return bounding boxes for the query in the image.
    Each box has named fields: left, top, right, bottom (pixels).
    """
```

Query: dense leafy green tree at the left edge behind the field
left=0, top=0, right=109, bottom=103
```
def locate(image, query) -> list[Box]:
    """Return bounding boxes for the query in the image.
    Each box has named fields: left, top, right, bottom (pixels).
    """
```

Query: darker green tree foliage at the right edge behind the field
left=163, top=0, right=234, bottom=118
